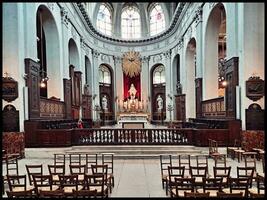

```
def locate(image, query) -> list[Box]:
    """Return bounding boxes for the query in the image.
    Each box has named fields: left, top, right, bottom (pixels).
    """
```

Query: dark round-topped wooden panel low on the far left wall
left=2, top=104, right=19, bottom=132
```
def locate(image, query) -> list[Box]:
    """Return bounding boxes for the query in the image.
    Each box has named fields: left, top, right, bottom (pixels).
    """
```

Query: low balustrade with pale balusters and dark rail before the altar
left=72, top=129, right=192, bottom=145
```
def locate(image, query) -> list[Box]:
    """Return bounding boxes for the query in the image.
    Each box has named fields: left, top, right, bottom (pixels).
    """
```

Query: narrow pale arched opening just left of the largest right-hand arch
left=185, top=38, right=196, bottom=118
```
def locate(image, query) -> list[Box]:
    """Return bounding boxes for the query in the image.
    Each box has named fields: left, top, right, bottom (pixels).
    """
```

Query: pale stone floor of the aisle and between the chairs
left=2, top=147, right=262, bottom=197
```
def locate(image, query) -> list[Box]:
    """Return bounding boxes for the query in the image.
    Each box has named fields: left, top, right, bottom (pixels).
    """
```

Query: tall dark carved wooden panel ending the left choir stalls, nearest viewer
left=25, top=58, right=40, bottom=119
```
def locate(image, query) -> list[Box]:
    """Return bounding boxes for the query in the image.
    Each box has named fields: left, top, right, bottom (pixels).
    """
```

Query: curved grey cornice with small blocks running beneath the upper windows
left=77, top=2, right=186, bottom=44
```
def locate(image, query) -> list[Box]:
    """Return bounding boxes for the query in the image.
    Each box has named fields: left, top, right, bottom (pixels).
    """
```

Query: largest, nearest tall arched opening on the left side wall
left=36, top=5, right=63, bottom=98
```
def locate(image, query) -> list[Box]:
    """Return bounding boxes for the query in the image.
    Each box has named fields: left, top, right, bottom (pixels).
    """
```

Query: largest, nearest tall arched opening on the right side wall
left=206, top=3, right=227, bottom=100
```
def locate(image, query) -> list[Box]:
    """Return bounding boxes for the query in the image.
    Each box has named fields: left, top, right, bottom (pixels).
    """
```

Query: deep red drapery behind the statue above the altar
left=123, top=73, right=141, bottom=101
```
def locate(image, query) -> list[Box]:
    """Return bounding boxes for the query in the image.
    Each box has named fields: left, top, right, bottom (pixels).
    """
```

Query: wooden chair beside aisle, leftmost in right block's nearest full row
left=171, top=177, right=195, bottom=198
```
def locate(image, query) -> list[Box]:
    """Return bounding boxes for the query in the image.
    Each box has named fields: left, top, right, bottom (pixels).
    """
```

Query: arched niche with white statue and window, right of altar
left=150, top=64, right=166, bottom=122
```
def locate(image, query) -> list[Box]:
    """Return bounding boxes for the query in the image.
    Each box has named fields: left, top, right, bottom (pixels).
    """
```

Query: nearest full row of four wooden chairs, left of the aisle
left=7, top=173, right=108, bottom=197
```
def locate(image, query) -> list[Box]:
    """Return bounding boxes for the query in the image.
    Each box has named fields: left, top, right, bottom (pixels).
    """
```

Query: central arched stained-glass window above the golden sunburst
left=121, top=5, right=141, bottom=39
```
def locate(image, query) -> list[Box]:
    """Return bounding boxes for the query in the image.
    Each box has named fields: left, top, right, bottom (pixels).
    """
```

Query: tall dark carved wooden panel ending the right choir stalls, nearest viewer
left=225, top=57, right=238, bottom=118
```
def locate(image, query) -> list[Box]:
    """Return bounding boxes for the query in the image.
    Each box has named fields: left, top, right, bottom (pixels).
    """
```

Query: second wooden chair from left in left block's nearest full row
left=32, top=174, right=59, bottom=197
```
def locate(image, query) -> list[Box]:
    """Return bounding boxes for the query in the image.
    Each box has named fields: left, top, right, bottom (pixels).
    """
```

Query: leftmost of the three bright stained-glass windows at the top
left=96, top=3, right=112, bottom=35
